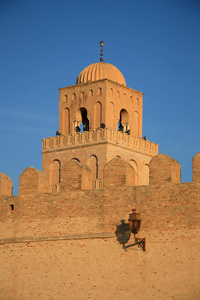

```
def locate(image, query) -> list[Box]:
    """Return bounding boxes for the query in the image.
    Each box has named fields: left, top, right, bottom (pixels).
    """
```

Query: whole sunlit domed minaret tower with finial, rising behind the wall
left=43, top=41, right=158, bottom=188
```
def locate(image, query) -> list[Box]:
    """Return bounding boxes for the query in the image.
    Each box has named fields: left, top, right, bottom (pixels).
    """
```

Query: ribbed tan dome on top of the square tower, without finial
left=76, top=62, right=126, bottom=86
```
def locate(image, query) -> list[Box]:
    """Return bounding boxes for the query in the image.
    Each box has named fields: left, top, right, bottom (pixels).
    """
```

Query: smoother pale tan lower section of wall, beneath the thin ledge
left=0, top=230, right=200, bottom=300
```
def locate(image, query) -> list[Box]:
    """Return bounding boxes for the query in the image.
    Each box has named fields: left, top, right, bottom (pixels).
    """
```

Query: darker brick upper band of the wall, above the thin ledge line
left=0, top=183, right=200, bottom=238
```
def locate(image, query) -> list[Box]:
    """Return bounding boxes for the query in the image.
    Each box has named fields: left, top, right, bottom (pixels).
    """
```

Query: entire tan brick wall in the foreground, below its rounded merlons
left=0, top=183, right=200, bottom=300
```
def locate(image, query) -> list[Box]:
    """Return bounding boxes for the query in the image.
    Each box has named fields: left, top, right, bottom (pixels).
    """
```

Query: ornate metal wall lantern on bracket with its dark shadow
left=115, top=209, right=146, bottom=251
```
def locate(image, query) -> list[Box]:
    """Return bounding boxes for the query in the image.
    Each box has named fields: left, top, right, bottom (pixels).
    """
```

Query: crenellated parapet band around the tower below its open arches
left=42, top=128, right=159, bottom=156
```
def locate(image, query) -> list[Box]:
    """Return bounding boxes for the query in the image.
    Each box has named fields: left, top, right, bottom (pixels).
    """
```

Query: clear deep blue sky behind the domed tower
left=0, top=0, right=200, bottom=194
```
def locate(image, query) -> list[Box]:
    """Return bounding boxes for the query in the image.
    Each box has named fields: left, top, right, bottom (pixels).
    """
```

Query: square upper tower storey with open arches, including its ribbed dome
left=59, top=61, right=143, bottom=138
